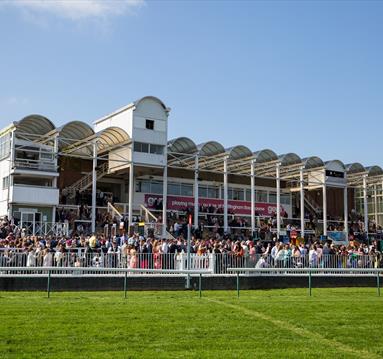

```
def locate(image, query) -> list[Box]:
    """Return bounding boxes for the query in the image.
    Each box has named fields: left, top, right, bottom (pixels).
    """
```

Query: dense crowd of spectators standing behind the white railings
left=0, top=211, right=381, bottom=273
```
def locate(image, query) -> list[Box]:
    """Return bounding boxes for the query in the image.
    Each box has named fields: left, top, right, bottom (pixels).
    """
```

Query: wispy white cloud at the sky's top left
left=1, top=0, right=145, bottom=21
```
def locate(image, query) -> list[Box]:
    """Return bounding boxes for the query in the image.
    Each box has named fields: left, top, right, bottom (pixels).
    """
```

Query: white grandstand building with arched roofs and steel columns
left=0, top=96, right=383, bottom=242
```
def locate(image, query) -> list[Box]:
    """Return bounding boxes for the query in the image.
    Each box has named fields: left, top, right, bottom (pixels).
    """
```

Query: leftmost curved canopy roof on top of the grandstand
left=14, top=115, right=55, bottom=139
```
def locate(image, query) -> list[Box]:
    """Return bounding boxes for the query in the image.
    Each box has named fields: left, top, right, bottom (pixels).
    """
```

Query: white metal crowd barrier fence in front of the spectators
left=0, top=248, right=383, bottom=274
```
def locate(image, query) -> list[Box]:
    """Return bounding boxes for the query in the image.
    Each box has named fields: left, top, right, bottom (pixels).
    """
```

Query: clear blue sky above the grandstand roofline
left=0, top=0, right=383, bottom=166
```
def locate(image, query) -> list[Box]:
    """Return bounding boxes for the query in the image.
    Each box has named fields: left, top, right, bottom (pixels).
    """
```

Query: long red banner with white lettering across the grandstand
left=145, top=194, right=287, bottom=216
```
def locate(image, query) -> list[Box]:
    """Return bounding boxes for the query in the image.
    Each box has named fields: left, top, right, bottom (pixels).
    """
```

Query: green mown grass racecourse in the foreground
left=0, top=288, right=383, bottom=359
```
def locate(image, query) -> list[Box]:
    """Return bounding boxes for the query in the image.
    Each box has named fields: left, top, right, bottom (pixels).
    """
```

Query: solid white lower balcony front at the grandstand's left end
left=10, top=185, right=59, bottom=206
